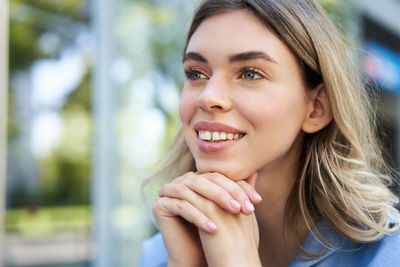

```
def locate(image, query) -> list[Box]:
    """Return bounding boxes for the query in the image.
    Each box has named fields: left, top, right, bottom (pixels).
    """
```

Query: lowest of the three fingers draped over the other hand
left=153, top=197, right=218, bottom=233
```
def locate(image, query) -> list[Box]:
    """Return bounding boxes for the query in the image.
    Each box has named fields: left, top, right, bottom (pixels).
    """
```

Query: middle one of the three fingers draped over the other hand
left=159, top=179, right=241, bottom=214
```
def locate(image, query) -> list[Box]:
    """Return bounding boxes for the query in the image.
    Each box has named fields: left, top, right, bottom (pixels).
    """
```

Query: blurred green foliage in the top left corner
left=9, top=0, right=89, bottom=70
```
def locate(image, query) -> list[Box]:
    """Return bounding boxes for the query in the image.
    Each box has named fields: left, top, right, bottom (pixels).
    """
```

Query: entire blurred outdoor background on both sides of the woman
left=0, top=0, right=400, bottom=267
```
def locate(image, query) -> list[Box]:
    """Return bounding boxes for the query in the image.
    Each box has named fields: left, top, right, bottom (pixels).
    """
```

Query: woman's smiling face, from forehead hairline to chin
left=180, top=10, right=309, bottom=180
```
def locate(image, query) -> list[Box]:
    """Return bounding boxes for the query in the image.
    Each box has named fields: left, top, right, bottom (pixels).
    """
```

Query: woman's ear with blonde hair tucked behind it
left=302, top=83, right=332, bottom=133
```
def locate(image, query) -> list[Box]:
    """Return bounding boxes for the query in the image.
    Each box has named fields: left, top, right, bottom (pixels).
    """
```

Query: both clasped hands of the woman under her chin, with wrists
left=153, top=172, right=261, bottom=266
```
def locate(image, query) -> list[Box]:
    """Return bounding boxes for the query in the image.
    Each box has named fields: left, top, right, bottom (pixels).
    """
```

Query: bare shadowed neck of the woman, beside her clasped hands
left=256, top=135, right=308, bottom=266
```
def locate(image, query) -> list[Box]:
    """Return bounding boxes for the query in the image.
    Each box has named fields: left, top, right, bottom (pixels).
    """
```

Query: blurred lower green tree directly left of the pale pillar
left=38, top=71, right=93, bottom=205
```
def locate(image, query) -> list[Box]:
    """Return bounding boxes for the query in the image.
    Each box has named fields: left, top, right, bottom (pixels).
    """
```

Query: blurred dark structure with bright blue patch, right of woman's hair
left=356, top=0, right=400, bottom=174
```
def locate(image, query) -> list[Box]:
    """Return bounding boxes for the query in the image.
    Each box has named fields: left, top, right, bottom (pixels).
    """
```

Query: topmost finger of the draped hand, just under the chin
left=202, top=172, right=254, bottom=215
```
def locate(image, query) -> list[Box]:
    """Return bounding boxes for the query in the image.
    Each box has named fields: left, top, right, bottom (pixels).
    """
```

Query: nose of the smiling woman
left=197, top=77, right=232, bottom=112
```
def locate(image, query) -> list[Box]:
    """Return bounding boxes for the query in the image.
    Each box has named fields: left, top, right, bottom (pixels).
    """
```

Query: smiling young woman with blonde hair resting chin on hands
left=140, top=0, right=400, bottom=267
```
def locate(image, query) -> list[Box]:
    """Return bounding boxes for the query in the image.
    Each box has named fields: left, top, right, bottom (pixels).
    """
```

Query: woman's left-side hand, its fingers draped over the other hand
left=153, top=172, right=261, bottom=266
